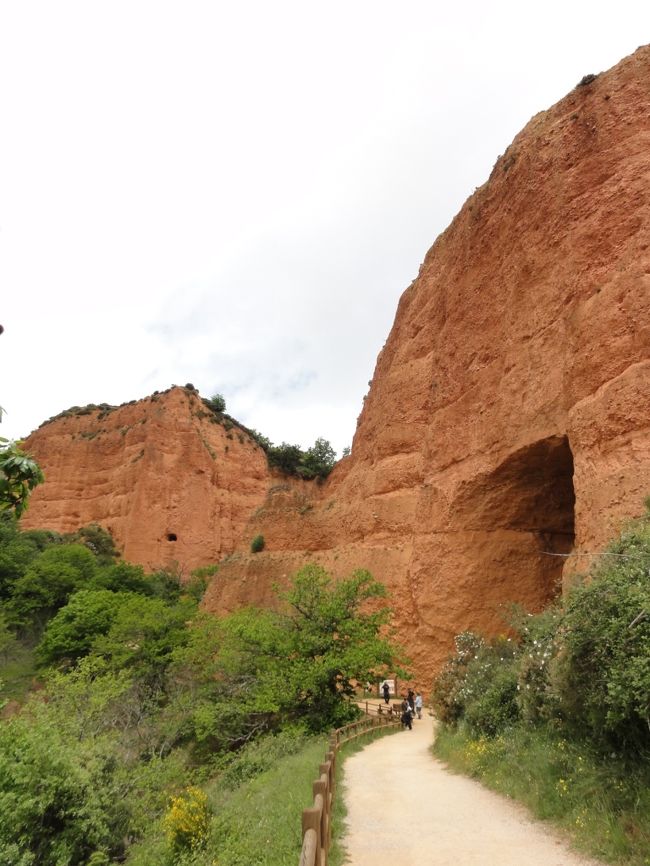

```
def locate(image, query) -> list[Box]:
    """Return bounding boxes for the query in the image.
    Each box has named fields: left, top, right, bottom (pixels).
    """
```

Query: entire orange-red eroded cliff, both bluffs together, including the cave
left=20, top=47, right=650, bottom=689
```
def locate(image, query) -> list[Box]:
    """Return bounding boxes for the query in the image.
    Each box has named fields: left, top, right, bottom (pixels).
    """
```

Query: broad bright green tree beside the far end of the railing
left=175, top=565, right=401, bottom=743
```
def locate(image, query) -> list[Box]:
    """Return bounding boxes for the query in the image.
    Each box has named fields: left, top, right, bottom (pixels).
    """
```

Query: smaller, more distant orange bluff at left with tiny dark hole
left=22, top=388, right=271, bottom=574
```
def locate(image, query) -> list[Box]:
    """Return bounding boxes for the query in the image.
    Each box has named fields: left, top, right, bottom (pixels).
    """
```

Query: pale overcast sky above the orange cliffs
left=0, top=0, right=650, bottom=452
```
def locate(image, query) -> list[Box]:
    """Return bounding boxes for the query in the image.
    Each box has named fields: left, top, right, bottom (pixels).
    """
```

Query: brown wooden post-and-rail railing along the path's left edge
left=299, top=701, right=400, bottom=866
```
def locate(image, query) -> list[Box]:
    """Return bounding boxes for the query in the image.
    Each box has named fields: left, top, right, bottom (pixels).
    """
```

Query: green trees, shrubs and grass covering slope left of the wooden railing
left=0, top=514, right=404, bottom=866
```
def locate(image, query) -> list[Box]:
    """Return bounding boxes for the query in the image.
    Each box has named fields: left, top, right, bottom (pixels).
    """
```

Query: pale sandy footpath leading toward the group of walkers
left=343, top=717, right=602, bottom=866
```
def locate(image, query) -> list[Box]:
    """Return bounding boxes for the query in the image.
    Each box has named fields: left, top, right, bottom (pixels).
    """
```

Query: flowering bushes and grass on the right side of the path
left=433, top=502, right=650, bottom=866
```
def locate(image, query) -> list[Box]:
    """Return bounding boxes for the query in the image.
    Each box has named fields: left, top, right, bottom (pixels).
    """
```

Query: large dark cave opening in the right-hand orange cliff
left=456, top=436, right=575, bottom=602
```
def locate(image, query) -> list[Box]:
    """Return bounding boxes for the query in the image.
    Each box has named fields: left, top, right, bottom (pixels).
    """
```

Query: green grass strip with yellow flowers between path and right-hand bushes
left=433, top=725, right=650, bottom=866
